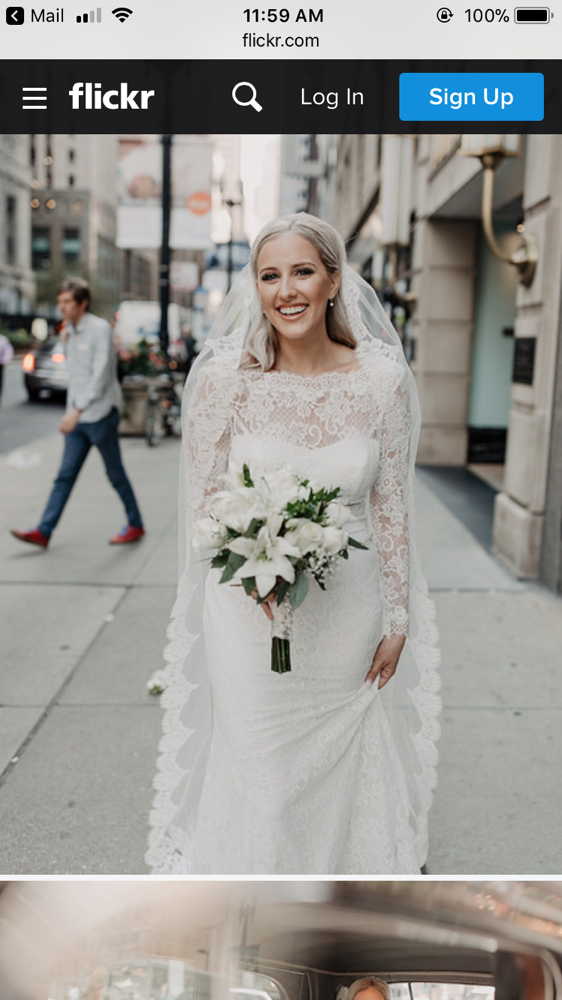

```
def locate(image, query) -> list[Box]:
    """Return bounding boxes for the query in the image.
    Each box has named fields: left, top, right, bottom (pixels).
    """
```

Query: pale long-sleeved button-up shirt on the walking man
left=66, top=312, right=121, bottom=423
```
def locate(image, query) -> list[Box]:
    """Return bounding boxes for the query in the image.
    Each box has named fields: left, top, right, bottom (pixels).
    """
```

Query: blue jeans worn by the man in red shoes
left=38, top=408, right=142, bottom=538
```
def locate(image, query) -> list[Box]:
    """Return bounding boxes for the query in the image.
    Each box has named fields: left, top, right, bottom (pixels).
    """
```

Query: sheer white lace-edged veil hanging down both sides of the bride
left=146, top=265, right=441, bottom=875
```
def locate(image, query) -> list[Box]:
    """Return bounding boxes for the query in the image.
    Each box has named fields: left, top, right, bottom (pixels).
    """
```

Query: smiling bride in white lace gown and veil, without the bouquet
left=146, top=213, right=439, bottom=875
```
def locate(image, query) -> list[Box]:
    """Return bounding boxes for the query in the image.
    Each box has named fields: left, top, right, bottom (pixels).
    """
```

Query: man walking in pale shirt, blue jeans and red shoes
left=12, top=278, right=144, bottom=549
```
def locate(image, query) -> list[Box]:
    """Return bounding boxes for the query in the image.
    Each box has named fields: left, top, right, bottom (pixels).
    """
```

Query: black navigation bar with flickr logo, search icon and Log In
left=0, top=59, right=562, bottom=133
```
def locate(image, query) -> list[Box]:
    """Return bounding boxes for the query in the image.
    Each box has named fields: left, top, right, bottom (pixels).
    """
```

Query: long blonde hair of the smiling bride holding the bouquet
left=240, top=212, right=357, bottom=371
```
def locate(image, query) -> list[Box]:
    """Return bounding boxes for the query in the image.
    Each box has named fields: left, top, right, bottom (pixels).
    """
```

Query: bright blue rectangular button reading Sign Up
left=400, top=73, right=544, bottom=122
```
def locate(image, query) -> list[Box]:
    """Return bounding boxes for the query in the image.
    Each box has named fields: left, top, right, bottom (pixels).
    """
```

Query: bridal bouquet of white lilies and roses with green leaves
left=193, top=465, right=367, bottom=674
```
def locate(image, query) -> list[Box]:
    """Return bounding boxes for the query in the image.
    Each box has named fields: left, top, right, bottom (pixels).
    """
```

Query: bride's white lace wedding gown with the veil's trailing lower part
left=147, top=343, right=439, bottom=875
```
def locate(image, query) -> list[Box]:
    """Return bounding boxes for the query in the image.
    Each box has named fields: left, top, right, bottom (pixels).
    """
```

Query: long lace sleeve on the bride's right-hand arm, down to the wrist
left=370, top=364, right=410, bottom=636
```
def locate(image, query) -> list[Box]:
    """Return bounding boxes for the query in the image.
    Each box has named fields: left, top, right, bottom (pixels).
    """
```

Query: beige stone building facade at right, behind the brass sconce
left=328, top=134, right=562, bottom=592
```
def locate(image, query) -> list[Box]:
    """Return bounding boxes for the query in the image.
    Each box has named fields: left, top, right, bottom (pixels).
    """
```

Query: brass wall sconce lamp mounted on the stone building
left=459, top=134, right=539, bottom=288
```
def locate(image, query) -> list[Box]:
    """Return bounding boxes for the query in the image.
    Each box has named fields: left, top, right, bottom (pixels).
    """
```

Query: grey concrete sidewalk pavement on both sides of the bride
left=0, top=435, right=562, bottom=875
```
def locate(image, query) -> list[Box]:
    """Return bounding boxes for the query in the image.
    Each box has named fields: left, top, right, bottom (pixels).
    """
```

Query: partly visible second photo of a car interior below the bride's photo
left=0, top=880, right=562, bottom=1000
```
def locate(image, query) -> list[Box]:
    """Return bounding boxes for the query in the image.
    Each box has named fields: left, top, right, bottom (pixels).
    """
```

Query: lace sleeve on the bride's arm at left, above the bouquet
left=184, top=361, right=235, bottom=518
